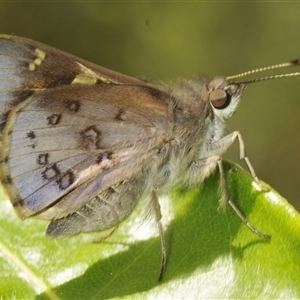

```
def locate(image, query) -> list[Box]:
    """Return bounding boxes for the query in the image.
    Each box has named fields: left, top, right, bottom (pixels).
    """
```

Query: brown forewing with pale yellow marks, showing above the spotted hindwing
left=0, top=35, right=156, bottom=138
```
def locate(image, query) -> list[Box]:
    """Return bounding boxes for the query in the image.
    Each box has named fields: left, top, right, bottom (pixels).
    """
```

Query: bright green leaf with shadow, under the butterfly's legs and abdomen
left=0, top=163, right=300, bottom=299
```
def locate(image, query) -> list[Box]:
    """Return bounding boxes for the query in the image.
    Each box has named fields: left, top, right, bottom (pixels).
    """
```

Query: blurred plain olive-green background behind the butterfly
left=0, top=2, right=300, bottom=210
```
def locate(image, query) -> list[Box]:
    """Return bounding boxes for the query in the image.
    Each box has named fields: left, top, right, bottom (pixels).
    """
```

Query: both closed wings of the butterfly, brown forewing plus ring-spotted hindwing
left=0, top=36, right=169, bottom=219
